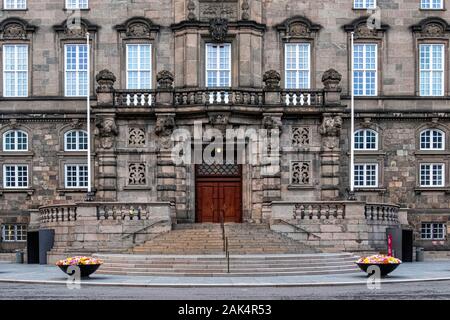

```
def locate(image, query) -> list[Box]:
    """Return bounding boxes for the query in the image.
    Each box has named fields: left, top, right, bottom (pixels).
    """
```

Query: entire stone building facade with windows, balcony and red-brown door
left=0, top=0, right=450, bottom=255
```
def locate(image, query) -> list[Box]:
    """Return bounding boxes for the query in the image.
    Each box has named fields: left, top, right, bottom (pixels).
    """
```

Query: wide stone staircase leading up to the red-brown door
left=95, top=224, right=358, bottom=277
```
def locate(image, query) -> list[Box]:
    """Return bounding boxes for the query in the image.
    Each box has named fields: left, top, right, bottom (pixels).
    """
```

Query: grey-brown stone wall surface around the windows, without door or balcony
left=0, top=0, right=450, bottom=250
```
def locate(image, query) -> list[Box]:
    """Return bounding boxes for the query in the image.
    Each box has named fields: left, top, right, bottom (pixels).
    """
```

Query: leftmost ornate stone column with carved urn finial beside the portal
left=94, top=69, right=119, bottom=201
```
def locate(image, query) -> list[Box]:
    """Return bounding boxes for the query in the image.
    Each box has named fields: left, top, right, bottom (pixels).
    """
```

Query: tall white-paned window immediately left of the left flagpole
left=64, top=44, right=88, bottom=97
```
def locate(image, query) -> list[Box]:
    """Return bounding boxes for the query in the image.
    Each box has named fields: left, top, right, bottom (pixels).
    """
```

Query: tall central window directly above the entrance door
left=206, top=44, right=231, bottom=87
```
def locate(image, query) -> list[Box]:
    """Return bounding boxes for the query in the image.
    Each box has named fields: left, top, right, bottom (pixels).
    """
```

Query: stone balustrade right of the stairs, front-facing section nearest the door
left=293, top=202, right=345, bottom=220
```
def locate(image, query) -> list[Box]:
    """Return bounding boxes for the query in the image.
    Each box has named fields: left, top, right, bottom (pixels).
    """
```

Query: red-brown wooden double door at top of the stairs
left=195, top=165, right=242, bottom=223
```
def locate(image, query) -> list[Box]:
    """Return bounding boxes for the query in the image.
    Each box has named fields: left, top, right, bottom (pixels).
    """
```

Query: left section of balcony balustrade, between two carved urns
left=114, top=89, right=156, bottom=108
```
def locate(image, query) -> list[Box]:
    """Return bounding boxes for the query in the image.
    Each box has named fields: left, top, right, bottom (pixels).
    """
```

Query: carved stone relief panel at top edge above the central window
left=199, top=0, right=239, bottom=21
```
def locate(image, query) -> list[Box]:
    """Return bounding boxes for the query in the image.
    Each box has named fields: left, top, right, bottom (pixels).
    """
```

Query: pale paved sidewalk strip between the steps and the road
left=0, top=260, right=450, bottom=287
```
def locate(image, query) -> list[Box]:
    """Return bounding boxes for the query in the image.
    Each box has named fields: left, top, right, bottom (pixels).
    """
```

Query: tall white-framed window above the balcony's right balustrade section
left=285, top=43, right=311, bottom=89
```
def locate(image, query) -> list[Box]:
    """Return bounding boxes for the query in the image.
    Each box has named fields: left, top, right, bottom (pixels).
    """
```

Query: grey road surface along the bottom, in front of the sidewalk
left=0, top=281, right=450, bottom=300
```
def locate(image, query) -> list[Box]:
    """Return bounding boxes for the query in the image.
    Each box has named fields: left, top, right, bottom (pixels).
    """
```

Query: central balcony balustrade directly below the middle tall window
left=174, top=88, right=264, bottom=106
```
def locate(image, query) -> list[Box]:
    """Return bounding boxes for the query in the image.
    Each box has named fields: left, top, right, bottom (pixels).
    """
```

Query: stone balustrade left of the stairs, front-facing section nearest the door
left=97, top=202, right=169, bottom=220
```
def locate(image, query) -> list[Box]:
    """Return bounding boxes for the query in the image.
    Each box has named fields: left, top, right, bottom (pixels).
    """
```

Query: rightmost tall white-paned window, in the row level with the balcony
left=419, top=44, right=445, bottom=96
